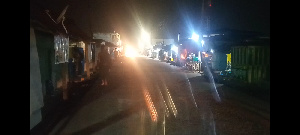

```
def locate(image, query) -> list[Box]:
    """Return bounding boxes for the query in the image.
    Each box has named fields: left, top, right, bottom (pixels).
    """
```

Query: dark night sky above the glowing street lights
left=31, top=0, right=270, bottom=44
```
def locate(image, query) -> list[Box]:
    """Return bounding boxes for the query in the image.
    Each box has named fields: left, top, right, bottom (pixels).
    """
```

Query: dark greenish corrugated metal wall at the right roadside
left=232, top=46, right=270, bottom=83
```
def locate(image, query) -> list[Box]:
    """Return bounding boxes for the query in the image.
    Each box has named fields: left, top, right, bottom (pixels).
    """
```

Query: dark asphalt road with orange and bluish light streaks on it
left=50, top=57, right=270, bottom=135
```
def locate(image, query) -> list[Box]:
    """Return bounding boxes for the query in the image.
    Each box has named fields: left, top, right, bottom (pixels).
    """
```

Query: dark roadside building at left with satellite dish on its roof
left=30, top=2, right=89, bottom=129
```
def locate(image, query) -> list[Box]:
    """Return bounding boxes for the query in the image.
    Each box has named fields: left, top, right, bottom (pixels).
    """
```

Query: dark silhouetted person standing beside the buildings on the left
left=97, top=45, right=111, bottom=85
